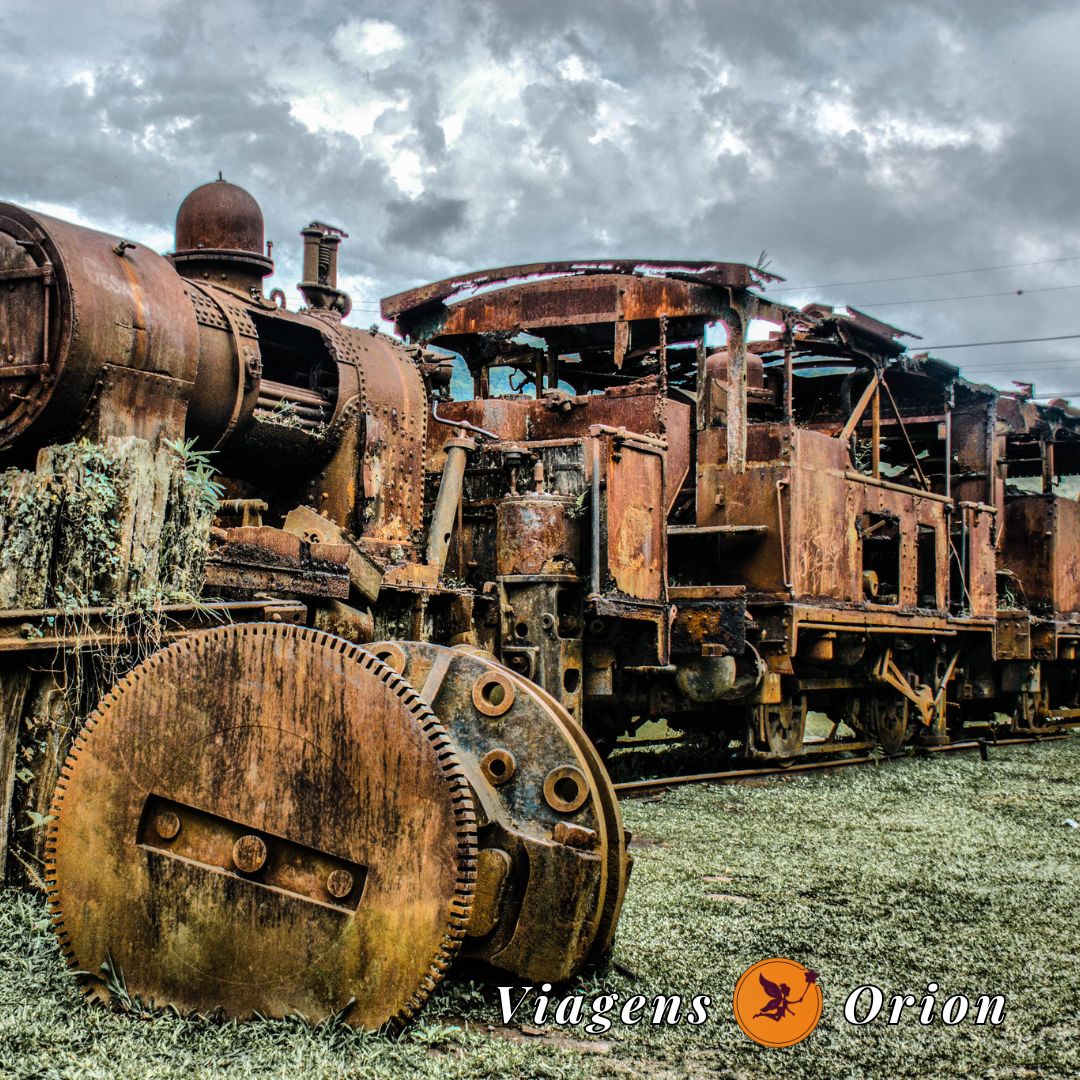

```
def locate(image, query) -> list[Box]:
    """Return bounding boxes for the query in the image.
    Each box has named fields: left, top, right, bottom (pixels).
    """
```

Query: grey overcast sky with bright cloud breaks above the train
left=0, top=0, right=1080, bottom=399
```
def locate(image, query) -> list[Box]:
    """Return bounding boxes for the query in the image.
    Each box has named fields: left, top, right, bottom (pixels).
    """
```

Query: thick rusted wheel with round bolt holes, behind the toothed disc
left=366, top=642, right=630, bottom=983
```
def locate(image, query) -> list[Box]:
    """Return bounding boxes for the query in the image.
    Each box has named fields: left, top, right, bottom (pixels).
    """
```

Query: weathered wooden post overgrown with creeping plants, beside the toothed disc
left=0, top=438, right=221, bottom=886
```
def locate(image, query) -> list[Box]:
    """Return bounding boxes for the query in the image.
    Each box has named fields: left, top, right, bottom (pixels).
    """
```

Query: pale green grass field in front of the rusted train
left=0, top=740, right=1080, bottom=1080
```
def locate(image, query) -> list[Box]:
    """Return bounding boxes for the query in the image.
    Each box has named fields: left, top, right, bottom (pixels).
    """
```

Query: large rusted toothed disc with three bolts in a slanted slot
left=48, top=624, right=476, bottom=1028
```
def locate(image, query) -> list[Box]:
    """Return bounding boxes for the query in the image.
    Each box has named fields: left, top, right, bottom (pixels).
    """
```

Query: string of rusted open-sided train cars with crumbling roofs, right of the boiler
left=383, top=270, right=1080, bottom=760
